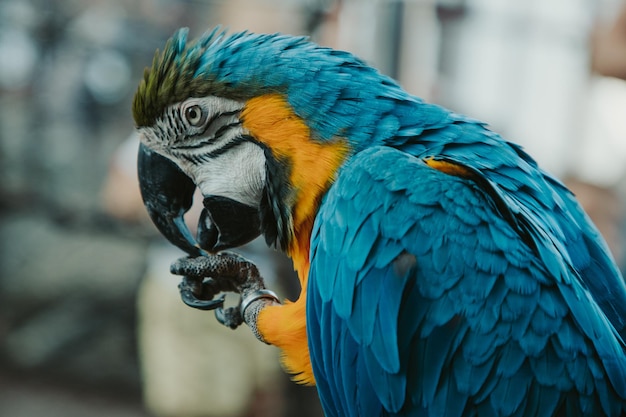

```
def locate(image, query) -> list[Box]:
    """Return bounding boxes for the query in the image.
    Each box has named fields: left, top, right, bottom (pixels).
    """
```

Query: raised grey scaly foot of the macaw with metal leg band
left=170, top=251, right=280, bottom=342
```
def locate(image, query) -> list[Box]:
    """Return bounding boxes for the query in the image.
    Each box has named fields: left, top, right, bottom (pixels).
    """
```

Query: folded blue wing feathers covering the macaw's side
left=307, top=141, right=626, bottom=417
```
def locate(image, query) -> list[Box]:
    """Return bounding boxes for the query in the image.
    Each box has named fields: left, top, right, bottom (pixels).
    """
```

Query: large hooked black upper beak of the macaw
left=137, top=143, right=204, bottom=257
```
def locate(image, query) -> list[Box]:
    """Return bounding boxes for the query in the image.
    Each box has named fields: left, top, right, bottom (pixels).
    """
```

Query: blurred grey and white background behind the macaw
left=0, top=0, right=626, bottom=417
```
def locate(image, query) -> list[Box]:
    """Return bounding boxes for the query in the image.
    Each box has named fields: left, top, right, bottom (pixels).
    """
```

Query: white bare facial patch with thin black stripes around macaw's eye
left=138, top=96, right=266, bottom=208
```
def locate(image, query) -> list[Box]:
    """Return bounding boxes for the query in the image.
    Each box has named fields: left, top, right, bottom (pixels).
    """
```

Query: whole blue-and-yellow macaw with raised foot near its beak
left=133, top=29, right=626, bottom=417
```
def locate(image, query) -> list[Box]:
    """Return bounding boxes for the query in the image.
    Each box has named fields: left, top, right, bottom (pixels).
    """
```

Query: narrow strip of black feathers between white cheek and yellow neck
left=257, top=142, right=293, bottom=250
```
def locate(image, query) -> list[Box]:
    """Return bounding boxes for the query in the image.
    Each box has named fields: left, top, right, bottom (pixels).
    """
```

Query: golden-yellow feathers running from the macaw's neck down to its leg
left=241, top=94, right=349, bottom=384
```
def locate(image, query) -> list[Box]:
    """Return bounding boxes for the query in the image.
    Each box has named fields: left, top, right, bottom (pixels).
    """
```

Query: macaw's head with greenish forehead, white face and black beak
left=132, top=29, right=361, bottom=256
